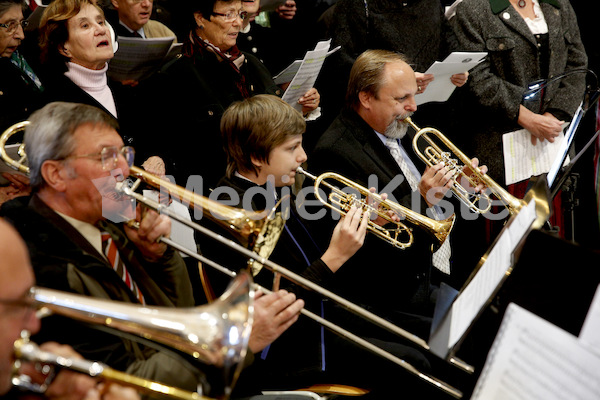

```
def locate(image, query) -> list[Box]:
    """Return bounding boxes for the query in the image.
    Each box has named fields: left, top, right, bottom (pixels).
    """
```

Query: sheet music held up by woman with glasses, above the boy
left=282, top=39, right=331, bottom=112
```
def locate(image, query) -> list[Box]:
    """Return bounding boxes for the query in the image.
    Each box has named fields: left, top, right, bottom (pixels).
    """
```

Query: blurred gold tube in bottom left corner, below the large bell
left=12, top=331, right=211, bottom=400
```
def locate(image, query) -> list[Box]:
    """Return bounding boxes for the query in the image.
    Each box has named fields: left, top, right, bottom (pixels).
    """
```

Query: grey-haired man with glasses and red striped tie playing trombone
left=0, top=102, right=304, bottom=391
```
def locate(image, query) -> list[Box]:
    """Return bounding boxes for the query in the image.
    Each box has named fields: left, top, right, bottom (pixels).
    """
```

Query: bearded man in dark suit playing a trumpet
left=308, top=50, right=486, bottom=339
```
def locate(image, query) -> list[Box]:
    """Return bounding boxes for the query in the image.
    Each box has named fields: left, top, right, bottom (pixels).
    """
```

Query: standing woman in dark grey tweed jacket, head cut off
left=451, top=0, right=587, bottom=239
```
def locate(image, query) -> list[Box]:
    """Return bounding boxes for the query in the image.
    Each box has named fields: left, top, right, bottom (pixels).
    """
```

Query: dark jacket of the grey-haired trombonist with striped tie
left=1, top=196, right=202, bottom=385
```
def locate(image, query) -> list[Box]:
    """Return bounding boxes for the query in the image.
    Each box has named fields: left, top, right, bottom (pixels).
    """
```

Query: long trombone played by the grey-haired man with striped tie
left=0, top=122, right=463, bottom=398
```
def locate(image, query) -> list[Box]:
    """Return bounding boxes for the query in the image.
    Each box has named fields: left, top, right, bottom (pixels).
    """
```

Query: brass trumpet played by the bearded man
left=404, top=117, right=527, bottom=215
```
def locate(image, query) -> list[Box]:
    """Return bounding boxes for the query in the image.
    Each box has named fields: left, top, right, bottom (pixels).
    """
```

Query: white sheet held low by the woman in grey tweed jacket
left=502, top=124, right=569, bottom=185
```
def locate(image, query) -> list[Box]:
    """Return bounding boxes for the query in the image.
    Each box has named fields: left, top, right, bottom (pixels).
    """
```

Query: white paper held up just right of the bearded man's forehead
left=415, top=52, right=487, bottom=106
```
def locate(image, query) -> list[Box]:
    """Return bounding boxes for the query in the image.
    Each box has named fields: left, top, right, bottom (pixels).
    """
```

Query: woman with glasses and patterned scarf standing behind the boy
left=149, top=0, right=319, bottom=189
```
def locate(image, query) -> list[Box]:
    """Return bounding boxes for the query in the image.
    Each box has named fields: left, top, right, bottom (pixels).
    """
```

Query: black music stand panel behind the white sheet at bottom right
left=457, top=230, right=600, bottom=398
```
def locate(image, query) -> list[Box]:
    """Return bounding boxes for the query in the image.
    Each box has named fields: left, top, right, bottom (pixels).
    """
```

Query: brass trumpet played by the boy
left=297, top=167, right=456, bottom=249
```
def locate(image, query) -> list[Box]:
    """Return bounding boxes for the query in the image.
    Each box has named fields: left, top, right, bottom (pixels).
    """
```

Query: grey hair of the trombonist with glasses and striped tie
left=24, top=102, right=118, bottom=190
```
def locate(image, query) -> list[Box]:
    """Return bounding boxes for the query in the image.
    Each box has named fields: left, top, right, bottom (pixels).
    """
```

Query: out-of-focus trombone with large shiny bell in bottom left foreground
left=15, top=273, right=254, bottom=399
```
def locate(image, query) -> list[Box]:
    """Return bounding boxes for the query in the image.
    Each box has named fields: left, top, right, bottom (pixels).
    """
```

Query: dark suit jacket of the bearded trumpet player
left=308, top=110, right=432, bottom=328
